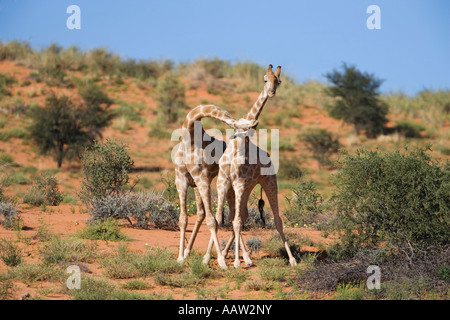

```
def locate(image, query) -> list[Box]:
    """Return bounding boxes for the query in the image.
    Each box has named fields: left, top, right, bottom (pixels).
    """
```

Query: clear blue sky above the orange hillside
left=0, top=0, right=450, bottom=94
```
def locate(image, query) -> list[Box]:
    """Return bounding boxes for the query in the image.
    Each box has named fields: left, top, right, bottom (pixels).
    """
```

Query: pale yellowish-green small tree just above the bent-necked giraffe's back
left=156, top=72, right=186, bottom=123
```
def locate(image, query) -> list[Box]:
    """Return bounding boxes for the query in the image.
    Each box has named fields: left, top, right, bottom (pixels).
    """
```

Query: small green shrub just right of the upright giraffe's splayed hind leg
left=284, top=179, right=323, bottom=226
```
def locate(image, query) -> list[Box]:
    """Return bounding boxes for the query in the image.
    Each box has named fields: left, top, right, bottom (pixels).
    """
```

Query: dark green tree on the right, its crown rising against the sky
left=326, top=63, right=388, bottom=137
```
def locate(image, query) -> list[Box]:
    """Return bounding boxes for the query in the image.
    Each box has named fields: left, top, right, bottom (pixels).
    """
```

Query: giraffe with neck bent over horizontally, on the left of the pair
left=172, top=105, right=252, bottom=268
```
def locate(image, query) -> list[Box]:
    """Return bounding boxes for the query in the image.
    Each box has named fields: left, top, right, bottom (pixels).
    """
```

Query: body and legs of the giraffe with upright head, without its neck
left=213, top=124, right=297, bottom=268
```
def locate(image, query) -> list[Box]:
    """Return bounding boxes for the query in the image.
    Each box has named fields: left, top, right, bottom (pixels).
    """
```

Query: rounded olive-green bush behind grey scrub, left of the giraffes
left=79, top=140, right=134, bottom=209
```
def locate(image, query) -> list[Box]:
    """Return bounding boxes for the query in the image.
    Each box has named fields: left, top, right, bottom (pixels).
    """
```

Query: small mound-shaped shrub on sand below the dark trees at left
left=23, top=174, right=63, bottom=206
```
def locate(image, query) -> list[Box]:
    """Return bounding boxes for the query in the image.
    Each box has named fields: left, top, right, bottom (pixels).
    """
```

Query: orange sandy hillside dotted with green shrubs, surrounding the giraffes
left=0, top=41, right=450, bottom=300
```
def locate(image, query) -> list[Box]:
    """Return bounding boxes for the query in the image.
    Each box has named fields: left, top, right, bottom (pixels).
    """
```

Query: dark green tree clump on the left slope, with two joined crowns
left=29, top=84, right=112, bottom=168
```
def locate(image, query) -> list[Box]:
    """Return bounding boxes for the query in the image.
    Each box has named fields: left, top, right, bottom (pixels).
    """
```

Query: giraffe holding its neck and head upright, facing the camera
left=203, top=65, right=296, bottom=267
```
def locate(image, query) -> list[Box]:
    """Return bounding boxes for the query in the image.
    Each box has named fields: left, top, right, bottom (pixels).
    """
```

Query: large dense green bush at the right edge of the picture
left=331, top=149, right=450, bottom=257
